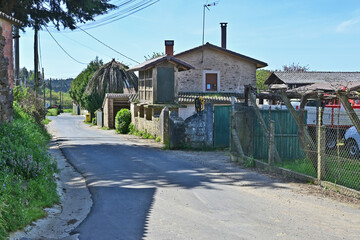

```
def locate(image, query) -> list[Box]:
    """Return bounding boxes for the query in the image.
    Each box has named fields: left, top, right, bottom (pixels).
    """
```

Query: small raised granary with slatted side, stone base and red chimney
left=129, top=40, right=193, bottom=138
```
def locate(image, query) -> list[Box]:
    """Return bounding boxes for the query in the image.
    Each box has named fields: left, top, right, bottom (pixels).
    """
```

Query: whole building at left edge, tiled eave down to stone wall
left=0, top=12, right=21, bottom=122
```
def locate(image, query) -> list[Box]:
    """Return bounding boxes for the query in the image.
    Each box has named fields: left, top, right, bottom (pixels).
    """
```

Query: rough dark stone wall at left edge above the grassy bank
left=0, top=24, right=13, bottom=122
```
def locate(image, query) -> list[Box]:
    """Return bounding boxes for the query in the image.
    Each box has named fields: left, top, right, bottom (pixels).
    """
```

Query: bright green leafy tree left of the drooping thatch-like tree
left=69, top=57, right=103, bottom=107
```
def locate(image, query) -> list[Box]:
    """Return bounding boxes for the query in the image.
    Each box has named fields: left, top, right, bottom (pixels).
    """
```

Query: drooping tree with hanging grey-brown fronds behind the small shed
left=82, top=60, right=138, bottom=113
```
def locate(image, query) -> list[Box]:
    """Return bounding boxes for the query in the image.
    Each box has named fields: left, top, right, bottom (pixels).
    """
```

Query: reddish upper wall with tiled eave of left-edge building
left=0, top=12, right=21, bottom=88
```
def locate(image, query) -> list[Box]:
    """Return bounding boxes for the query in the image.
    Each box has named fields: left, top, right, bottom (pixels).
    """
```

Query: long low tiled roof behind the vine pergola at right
left=265, top=72, right=360, bottom=85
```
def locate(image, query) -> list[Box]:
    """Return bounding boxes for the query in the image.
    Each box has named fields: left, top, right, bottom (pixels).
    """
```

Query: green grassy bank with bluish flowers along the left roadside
left=0, top=104, right=58, bottom=239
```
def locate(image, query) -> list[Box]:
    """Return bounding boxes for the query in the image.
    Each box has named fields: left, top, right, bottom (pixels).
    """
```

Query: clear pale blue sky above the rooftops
left=20, top=0, right=360, bottom=79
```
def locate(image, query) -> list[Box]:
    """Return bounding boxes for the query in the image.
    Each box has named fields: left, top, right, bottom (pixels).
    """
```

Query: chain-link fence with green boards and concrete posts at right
left=231, top=98, right=360, bottom=191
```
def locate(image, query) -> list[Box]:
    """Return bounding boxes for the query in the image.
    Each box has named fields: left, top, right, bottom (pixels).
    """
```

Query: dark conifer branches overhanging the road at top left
left=0, top=0, right=116, bottom=30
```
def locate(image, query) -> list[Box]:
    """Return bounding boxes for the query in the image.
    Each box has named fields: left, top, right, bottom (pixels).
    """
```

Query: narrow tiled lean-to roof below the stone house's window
left=175, top=92, right=244, bottom=104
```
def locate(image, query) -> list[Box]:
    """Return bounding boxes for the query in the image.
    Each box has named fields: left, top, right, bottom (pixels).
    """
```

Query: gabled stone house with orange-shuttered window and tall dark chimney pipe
left=174, top=23, right=267, bottom=119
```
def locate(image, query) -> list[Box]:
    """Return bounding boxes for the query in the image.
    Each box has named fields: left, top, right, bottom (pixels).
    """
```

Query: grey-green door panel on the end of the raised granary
left=156, top=67, right=175, bottom=103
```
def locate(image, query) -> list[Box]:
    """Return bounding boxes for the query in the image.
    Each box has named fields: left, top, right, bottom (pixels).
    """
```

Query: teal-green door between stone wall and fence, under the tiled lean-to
left=214, top=106, right=231, bottom=147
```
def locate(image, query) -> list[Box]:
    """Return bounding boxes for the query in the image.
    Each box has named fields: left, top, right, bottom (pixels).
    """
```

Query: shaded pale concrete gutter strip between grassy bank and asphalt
left=10, top=137, right=93, bottom=240
